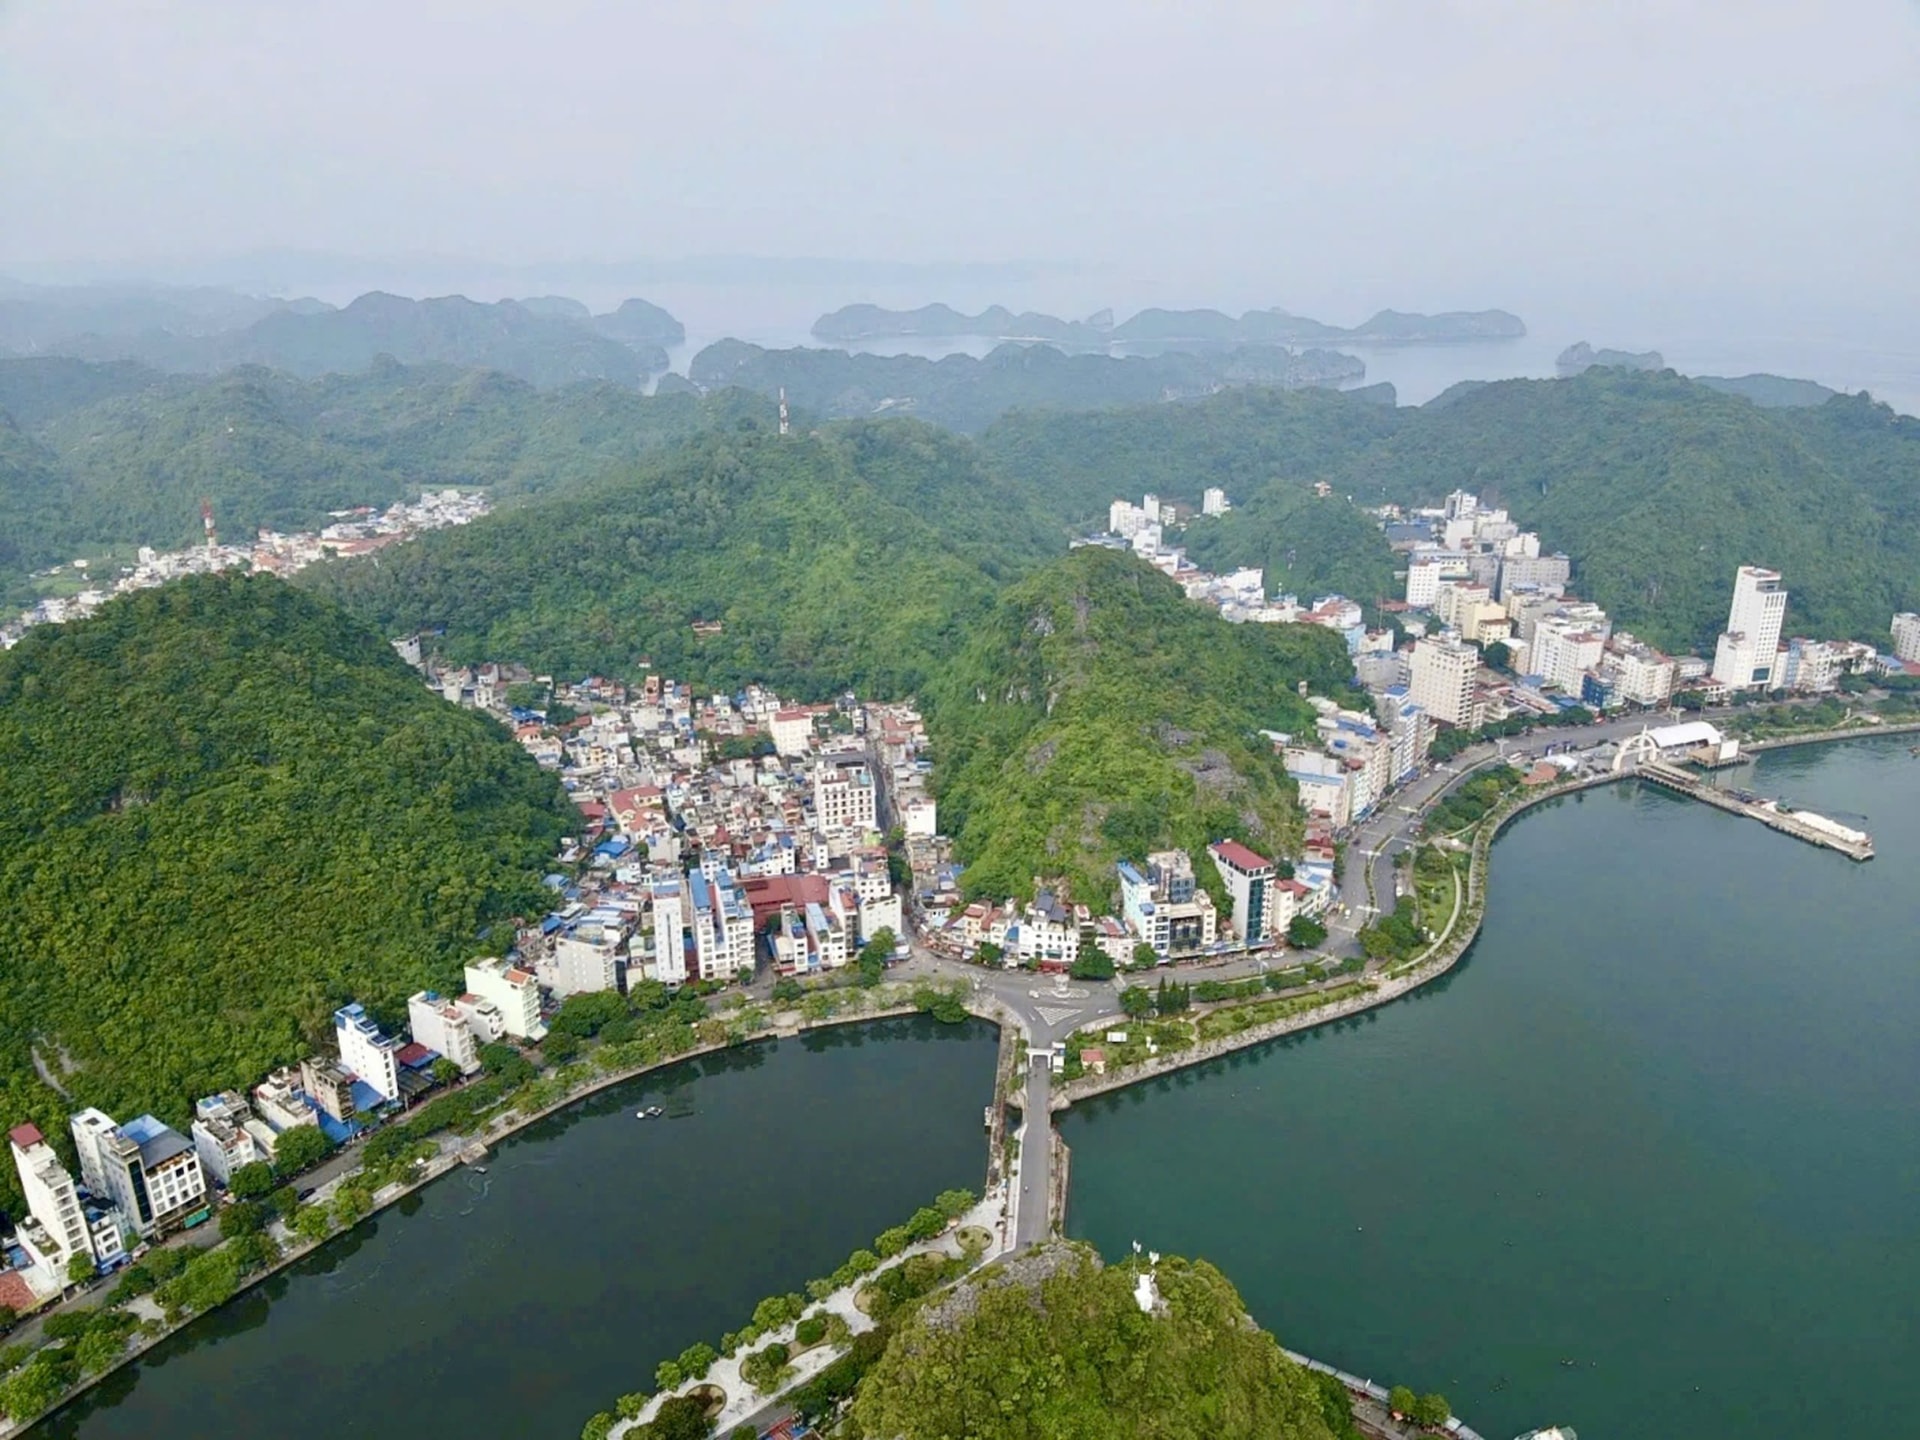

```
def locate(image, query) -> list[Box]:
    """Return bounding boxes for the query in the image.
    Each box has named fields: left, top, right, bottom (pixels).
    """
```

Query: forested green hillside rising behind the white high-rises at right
left=1334, top=371, right=1920, bottom=655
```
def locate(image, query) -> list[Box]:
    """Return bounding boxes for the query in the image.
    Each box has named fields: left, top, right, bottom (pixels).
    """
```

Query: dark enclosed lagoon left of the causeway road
left=33, top=1018, right=996, bottom=1440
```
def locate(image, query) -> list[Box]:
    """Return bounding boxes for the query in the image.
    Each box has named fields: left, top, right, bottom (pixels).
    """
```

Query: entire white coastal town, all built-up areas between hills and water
left=0, top=492, right=1920, bottom=1440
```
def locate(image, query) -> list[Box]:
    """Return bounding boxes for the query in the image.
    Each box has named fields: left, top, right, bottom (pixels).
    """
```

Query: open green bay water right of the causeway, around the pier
left=1064, top=741, right=1920, bottom=1440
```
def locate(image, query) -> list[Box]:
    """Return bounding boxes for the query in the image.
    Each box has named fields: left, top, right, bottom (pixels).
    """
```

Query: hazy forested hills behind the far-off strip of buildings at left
left=0, top=357, right=766, bottom=578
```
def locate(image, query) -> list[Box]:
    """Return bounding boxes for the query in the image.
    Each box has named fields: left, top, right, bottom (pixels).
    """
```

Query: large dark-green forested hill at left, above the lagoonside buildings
left=0, top=576, right=572, bottom=1183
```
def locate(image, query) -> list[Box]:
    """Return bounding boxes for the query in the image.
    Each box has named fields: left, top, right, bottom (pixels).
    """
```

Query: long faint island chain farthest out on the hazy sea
left=812, top=305, right=1526, bottom=349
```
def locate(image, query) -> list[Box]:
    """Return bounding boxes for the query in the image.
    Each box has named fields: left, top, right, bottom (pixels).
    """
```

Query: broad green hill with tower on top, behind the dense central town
left=303, top=420, right=1064, bottom=697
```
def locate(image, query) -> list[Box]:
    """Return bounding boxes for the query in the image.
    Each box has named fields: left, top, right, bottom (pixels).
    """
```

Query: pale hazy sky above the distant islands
left=0, top=0, right=1920, bottom=326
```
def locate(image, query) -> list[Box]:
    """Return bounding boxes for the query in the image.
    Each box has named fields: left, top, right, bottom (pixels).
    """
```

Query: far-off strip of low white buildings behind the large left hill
left=0, top=490, right=490, bottom=647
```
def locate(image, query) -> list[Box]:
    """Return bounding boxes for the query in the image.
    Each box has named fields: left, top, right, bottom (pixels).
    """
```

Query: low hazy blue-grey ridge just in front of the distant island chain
left=687, top=340, right=1367, bottom=432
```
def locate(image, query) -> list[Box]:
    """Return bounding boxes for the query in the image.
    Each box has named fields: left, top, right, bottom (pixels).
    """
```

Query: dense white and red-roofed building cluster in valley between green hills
left=418, top=664, right=921, bottom=998
